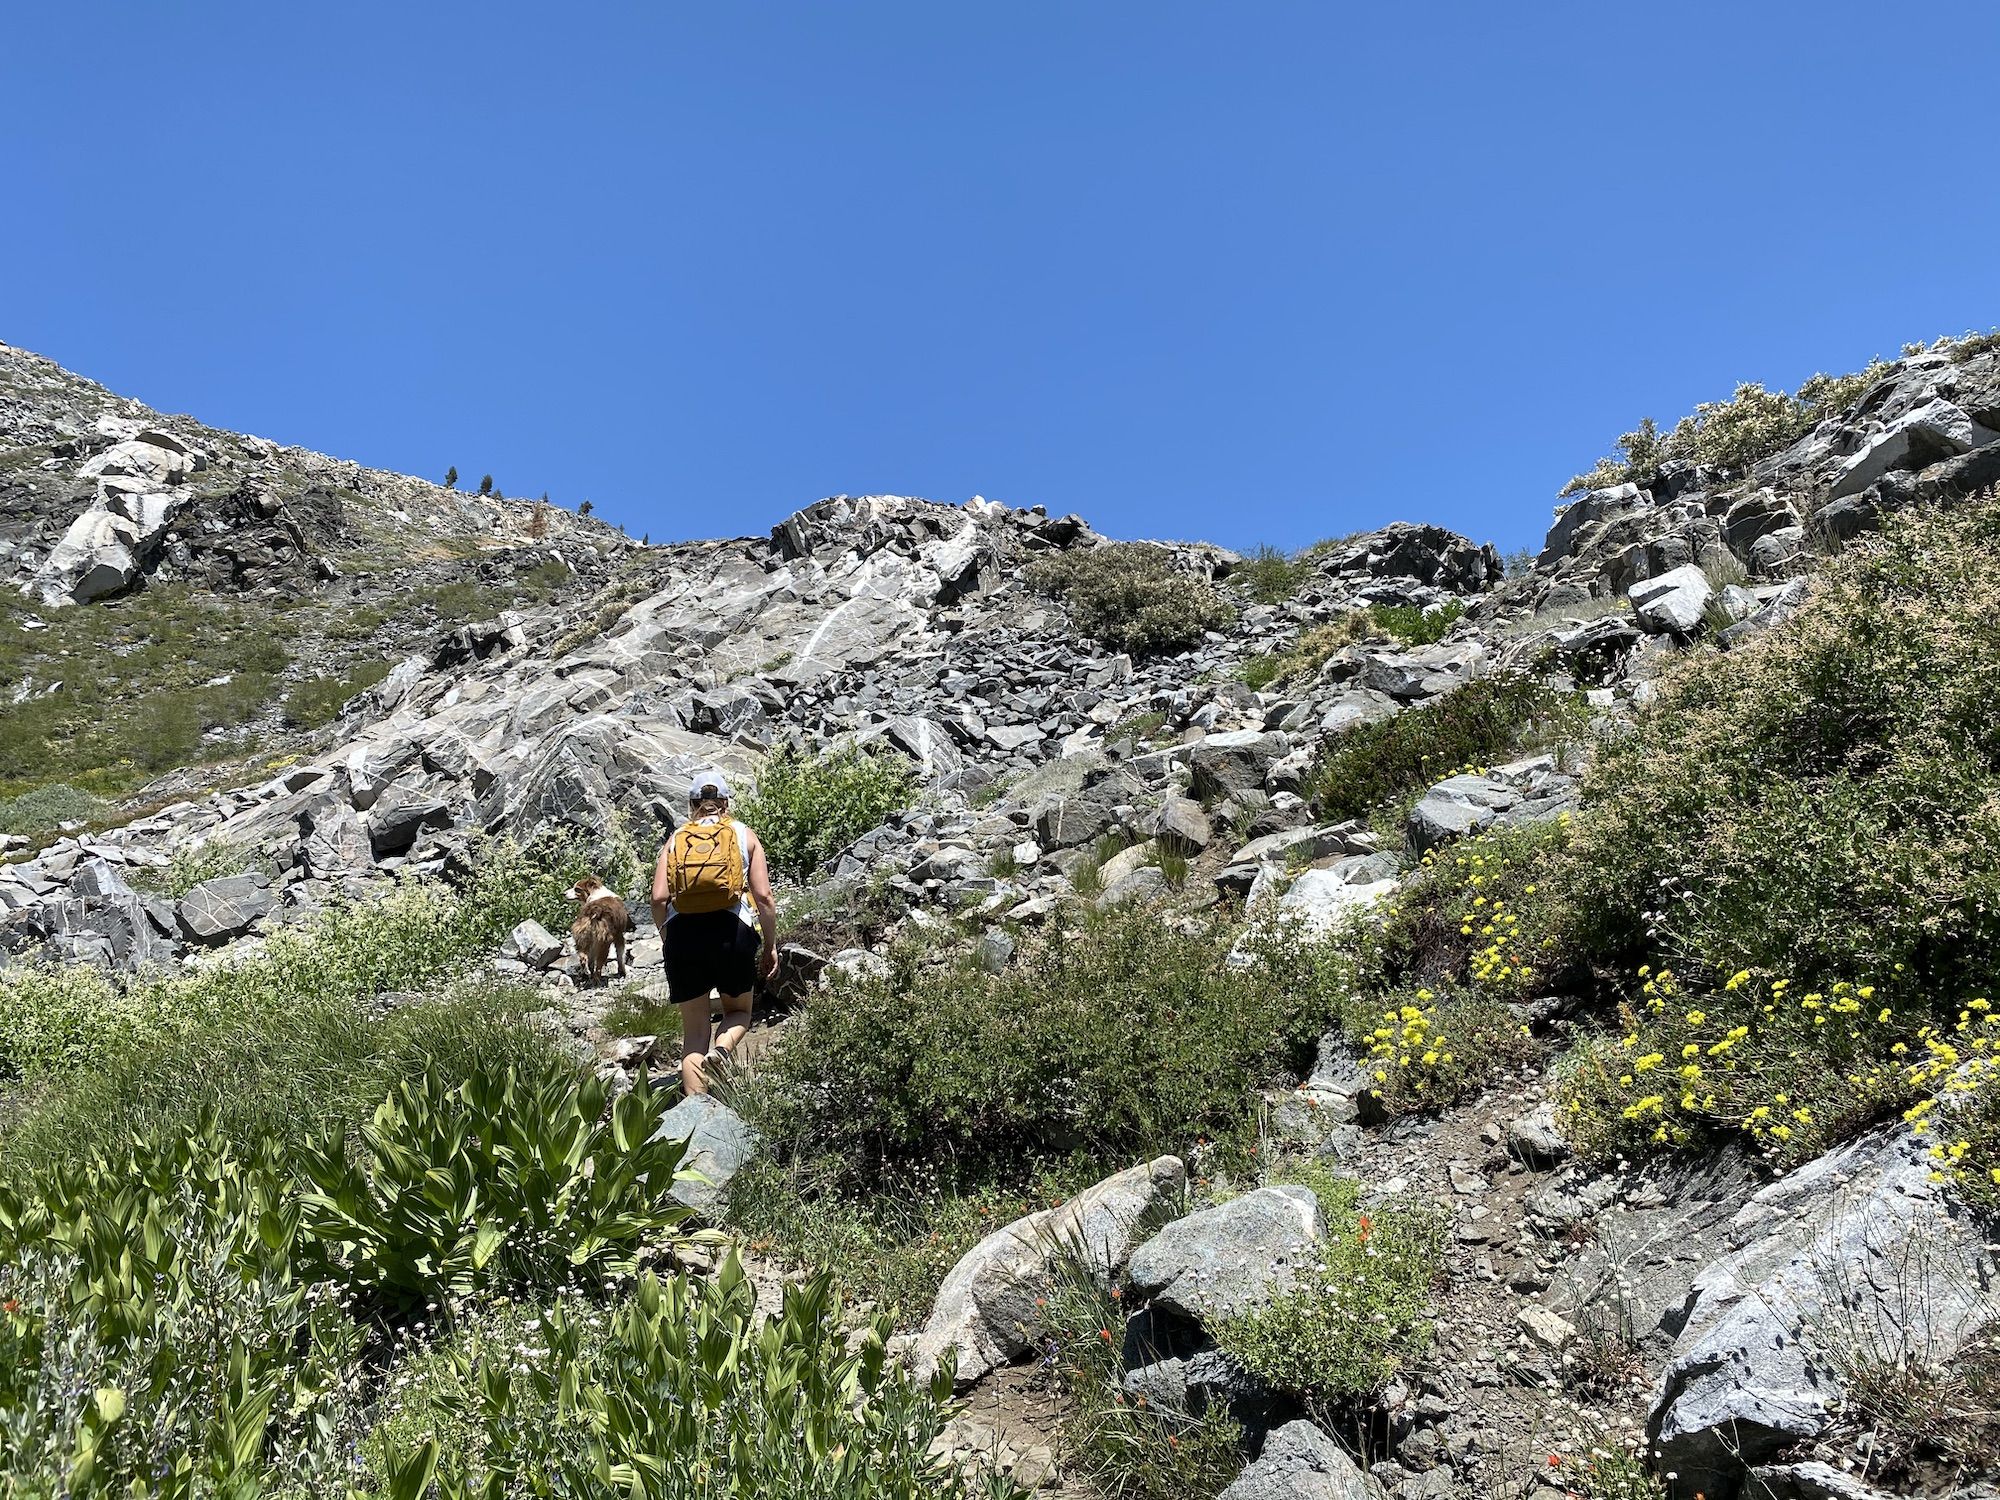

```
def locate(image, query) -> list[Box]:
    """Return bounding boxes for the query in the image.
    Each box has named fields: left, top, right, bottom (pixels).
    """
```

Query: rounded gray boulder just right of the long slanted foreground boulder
left=1126, top=1184, right=1322, bottom=1324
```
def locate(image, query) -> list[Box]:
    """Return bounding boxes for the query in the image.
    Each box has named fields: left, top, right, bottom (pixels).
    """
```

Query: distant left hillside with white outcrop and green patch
left=0, top=346, right=632, bottom=812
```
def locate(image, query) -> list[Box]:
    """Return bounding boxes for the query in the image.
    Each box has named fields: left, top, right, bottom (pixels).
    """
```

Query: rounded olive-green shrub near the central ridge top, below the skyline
left=1026, top=542, right=1236, bottom=654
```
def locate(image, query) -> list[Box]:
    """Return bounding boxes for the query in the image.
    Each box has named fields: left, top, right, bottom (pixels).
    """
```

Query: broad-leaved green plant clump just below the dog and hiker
left=296, top=1064, right=688, bottom=1302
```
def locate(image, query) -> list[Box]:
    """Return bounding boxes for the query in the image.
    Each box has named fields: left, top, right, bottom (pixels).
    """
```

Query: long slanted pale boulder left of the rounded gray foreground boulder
left=910, top=1156, right=1188, bottom=1386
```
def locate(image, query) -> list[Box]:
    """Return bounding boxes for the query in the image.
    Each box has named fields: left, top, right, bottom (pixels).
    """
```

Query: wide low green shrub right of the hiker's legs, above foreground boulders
left=742, top=904, right=1346, bottom=1190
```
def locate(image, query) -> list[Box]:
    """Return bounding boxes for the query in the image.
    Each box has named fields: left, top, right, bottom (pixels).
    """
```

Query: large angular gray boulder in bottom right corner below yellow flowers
left=1648, top=1126, right=1996, bottom=1494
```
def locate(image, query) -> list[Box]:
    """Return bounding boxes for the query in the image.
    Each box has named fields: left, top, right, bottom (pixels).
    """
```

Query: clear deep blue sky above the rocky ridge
left=0, top=0, right=2000, bottom=548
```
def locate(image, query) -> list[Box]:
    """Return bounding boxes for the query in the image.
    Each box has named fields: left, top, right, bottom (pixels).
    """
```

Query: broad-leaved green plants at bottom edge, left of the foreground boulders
left=378, top=1258, right=1020, bottom=1500
